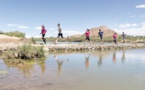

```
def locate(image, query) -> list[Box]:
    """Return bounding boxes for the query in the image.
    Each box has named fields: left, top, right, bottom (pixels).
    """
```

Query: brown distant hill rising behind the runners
left=71, top=26, right=120, bottom=37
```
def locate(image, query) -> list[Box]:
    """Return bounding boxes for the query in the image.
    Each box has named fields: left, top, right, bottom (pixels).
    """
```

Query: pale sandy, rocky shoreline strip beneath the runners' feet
left=0, top=43, right=145, bottom=52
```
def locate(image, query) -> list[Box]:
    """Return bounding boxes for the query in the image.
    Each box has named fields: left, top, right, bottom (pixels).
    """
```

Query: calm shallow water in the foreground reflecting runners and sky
left=0, top=49, right=145, bottom=90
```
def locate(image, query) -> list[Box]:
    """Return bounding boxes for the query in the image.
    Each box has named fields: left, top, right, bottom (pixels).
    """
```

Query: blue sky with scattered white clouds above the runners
left=0, top=0, right=145, bottom=37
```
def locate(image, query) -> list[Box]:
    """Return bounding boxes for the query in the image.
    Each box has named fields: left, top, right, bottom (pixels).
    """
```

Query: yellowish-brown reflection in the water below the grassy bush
left=4, top=58, right=45, bottom=76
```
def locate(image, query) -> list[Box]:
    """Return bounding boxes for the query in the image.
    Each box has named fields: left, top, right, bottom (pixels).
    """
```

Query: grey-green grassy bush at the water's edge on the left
left=3, top=45, right=44, bottom=60
